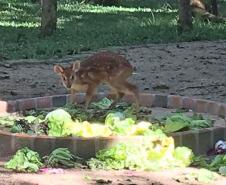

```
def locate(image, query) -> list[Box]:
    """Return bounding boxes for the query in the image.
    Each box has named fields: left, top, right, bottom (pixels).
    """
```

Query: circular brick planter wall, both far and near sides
left=0, top=94, right=226, bottom=159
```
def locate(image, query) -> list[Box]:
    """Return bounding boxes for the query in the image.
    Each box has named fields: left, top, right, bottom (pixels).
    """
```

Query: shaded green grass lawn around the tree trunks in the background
left=0, top=0, right=226, bottom=59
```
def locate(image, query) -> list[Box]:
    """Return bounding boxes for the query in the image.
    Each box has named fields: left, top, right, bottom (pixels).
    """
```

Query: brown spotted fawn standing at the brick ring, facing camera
left=54, top=52, right=139, bottom=110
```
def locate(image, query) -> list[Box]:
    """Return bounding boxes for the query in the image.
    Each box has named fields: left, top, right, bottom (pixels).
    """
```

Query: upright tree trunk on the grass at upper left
left=41, top=0, right=57, bottom=37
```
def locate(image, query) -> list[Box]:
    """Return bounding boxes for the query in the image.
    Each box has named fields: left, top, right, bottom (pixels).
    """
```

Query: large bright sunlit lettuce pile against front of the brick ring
left=88, top=130, right=193, bottom=170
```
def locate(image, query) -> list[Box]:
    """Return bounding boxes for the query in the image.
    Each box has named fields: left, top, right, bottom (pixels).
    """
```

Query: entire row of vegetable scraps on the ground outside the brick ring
left=4, top=146, right=222, bottom=184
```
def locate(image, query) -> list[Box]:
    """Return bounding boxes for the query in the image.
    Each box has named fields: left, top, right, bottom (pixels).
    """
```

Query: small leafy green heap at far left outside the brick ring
left=4, top=147, right=43, bottom=172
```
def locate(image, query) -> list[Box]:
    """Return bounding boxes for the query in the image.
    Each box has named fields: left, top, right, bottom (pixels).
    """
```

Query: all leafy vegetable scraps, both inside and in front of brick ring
left=0, top=98, right=222, bottom=182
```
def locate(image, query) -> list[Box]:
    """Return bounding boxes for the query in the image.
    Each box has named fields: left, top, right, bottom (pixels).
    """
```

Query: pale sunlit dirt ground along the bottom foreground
left=0, top=164, right=226, bottom=185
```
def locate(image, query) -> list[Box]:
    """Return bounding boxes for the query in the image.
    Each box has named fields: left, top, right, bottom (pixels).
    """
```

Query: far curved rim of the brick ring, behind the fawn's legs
left=0, top=93, right=226, bottom=118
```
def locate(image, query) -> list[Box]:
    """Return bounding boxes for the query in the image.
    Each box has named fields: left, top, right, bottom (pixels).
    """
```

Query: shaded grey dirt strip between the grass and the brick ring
left=0, top=41, right=226, bottom=102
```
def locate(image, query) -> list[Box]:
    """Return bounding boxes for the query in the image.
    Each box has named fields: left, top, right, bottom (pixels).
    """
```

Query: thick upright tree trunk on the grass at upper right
left=178, top=0, right=192, bottom=32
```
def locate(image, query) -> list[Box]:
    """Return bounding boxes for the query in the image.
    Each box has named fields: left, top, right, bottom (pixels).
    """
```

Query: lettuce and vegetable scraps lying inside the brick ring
left=0, top=98, right=213, bottom=137
